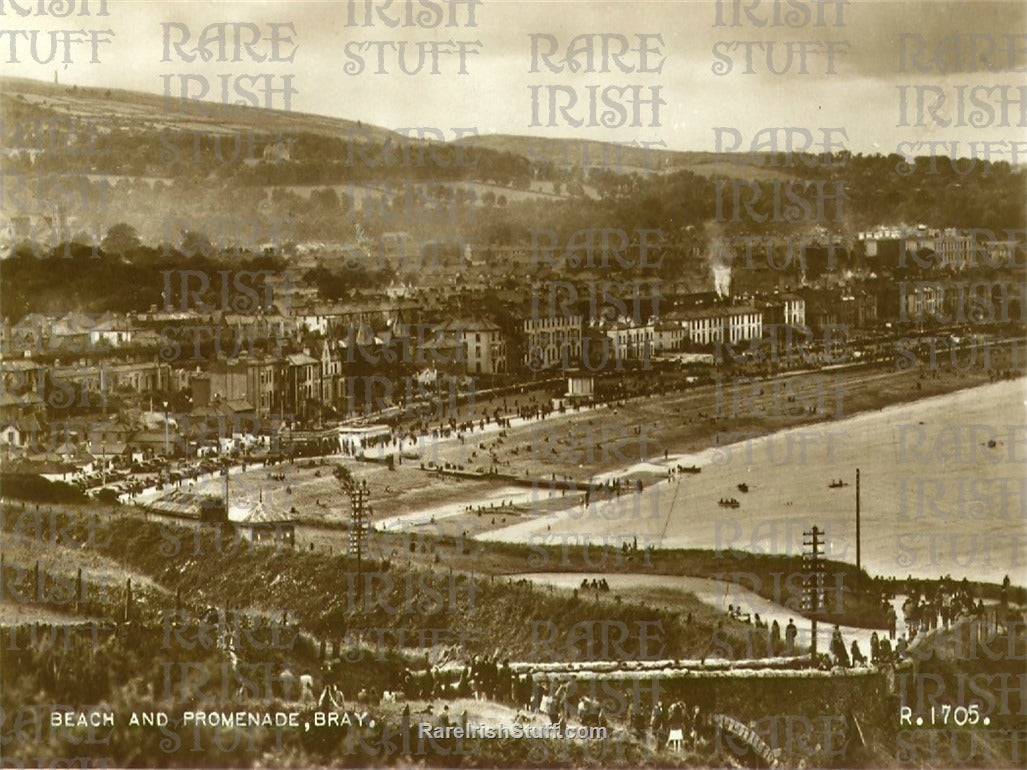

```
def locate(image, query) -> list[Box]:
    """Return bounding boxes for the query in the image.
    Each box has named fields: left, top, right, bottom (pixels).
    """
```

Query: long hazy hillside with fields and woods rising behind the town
left=0, top=78, right=1027, bottom=291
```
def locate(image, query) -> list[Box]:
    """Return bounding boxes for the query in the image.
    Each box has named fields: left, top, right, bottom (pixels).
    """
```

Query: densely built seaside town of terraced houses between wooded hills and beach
left=0, top=218, right=1025, bottom=513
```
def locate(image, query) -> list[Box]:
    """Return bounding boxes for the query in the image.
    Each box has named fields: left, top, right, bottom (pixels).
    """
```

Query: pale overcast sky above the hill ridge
left=0, top=0, right=1027, bottom=160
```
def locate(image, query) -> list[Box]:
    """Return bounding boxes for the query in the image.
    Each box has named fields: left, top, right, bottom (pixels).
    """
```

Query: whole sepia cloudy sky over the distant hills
left=0, top=0, right=1027, bottom=157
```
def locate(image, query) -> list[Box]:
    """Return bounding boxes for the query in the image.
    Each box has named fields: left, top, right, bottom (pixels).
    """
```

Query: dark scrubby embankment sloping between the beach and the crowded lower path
left=4, top=512, right=768, bottom=660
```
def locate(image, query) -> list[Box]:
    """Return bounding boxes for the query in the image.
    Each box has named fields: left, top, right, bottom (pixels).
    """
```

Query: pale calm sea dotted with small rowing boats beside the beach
left=479, top=379, right=1027, bottom=582
